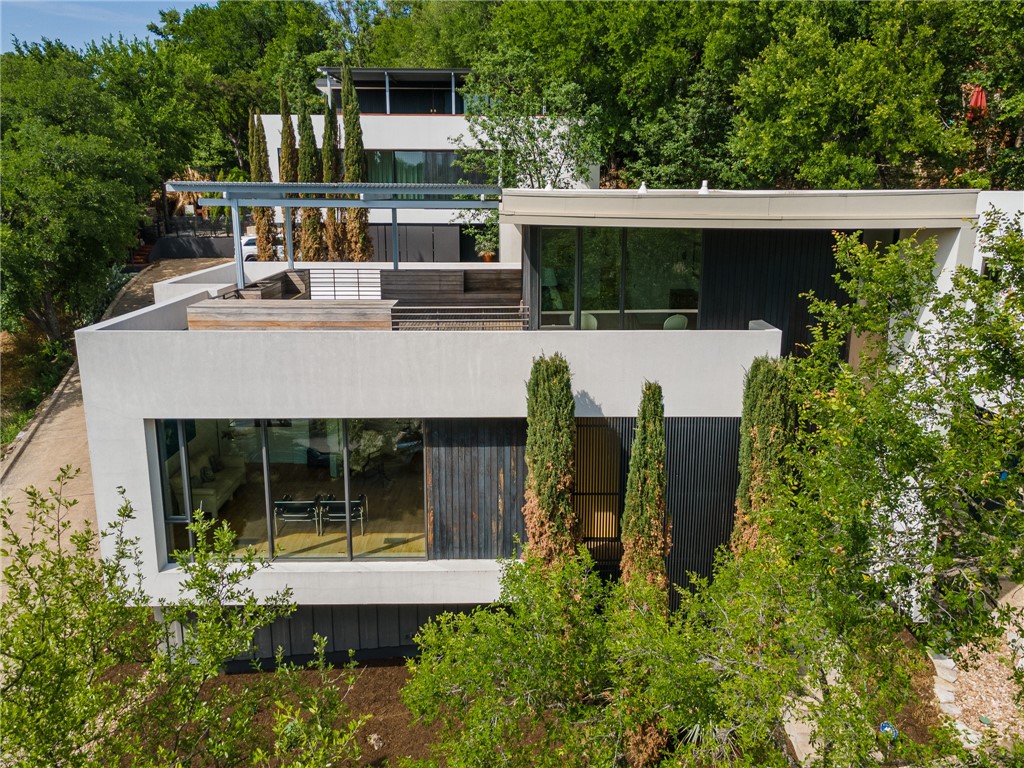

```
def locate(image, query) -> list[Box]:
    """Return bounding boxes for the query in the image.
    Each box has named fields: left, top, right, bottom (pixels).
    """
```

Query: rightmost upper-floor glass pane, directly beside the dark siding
left=626, top=229, right=702, bottom=330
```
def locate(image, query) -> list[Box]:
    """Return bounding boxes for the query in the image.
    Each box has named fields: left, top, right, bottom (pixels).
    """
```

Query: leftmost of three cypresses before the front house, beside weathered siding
left=523, top=353, right=578, bottom=565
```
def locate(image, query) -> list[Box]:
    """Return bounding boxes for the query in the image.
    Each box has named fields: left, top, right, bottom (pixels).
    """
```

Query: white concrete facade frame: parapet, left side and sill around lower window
left=77, top=303, right=780, bottom=605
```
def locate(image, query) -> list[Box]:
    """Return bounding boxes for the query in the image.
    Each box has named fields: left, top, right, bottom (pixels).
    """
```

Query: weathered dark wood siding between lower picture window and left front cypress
left=423, top=419, right=526, bottom=560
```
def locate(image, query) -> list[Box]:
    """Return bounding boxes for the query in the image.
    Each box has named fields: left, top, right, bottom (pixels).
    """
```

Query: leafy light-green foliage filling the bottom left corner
left=0, top=468, right=368, bottom=768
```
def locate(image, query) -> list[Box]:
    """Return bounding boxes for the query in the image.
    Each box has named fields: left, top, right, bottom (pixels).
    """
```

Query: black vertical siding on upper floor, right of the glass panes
left=700, top=229, right=846, bottom=354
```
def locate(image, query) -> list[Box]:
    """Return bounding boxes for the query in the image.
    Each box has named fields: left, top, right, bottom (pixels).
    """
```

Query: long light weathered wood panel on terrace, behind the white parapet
left=187, top=299, right=395, bottom=331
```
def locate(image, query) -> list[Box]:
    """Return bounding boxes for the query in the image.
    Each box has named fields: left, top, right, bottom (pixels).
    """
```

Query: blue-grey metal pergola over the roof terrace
left=165, top=181, right=502, bottom=288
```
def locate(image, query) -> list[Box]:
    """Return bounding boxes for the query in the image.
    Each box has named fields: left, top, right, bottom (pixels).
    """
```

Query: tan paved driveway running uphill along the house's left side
left=0, top=259, right=226, bottom=599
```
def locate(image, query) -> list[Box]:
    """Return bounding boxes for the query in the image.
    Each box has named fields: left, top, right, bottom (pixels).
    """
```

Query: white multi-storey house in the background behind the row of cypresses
left=263, top=67, right=598, bottom=262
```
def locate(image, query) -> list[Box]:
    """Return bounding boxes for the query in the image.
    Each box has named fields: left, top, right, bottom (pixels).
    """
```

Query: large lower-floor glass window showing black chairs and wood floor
left=156, top=419, right=427, bottom=559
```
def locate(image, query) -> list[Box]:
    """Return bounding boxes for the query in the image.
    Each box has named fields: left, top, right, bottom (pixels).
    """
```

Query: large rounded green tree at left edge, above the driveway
left=0, top=43, right=156, bottom=339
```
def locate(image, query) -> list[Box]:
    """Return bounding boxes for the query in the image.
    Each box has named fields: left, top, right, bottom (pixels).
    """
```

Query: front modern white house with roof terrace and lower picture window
left=77, top=184, right=1024, bottom=655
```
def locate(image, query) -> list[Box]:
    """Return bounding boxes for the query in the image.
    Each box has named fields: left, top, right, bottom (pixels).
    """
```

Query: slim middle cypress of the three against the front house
left=622, top=382, right=670, bottom=598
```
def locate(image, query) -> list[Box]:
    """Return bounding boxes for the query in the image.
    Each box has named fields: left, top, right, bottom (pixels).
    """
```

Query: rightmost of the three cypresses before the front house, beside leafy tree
left=732, top=357, right=798, bottom=551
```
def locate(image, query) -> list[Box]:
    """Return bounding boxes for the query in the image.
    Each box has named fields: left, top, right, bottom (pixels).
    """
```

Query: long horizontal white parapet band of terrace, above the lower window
left=77, top=325, right=780, bottom=419
